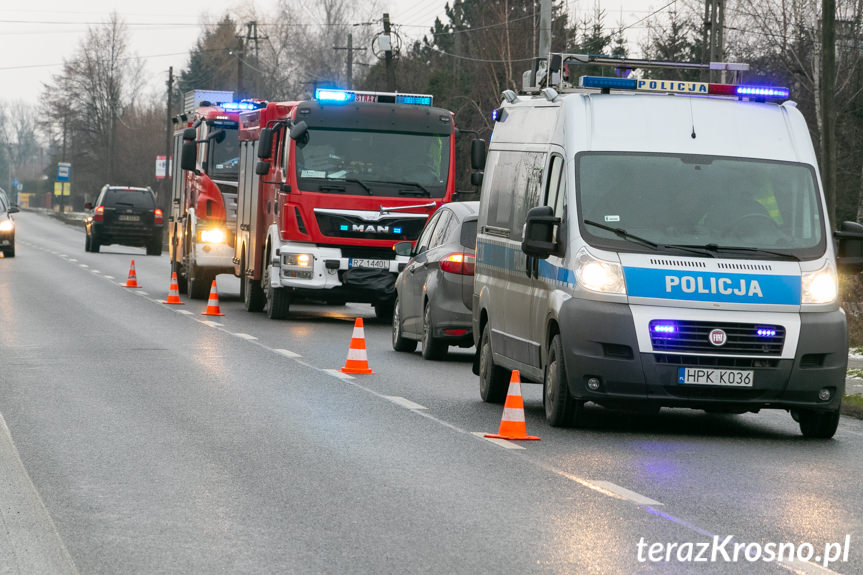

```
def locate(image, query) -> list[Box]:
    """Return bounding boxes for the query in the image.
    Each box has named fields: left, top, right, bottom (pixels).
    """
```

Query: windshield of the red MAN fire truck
left=296, top=128, right=450, bottom=198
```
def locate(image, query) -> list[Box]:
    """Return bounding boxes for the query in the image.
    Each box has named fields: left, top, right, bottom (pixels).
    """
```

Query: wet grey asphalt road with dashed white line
left=0, top=213, right=863, bottom=574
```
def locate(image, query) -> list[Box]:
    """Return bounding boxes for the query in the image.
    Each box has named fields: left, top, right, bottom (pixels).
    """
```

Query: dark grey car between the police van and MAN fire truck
left=393, top=202, right=479, bottom=359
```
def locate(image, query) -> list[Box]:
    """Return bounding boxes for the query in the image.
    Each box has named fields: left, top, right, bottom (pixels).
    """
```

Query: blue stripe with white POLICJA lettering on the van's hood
left=623, top=267, right=801, bottom=305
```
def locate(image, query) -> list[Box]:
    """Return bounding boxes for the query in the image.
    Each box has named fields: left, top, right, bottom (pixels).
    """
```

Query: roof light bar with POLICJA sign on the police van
left=578, top=76, right=791, bottom=100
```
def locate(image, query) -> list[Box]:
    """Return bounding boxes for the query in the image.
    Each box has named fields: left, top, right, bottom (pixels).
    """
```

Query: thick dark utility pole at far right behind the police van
left=820, top=0, right=836, bottom=227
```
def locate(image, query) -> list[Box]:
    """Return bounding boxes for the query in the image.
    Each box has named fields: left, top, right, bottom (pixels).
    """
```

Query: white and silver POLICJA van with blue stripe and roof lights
left=472, top=55, right=863, bottom=438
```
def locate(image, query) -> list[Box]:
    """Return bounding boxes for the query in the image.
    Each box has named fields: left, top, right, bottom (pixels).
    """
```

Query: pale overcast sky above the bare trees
left=0, top=0, right=656, bottom=103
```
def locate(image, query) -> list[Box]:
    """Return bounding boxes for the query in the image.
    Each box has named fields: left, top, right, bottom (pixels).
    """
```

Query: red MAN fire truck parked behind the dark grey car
left=234, top=89, right=455, bottom=319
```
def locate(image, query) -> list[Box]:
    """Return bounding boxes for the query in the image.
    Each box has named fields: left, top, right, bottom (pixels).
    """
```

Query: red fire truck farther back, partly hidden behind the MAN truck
left=168, top=90, right=258, bottom=299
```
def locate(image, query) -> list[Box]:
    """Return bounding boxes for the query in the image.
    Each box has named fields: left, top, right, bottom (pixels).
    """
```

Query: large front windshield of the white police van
left=575, top=152, right=826, bottom=259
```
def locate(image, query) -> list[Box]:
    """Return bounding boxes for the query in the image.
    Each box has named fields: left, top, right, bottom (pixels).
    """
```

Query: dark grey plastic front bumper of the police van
left=559, top=298, right=848, bottom=411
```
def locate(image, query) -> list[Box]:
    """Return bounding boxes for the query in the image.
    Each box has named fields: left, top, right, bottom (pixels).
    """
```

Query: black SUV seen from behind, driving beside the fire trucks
left=84, top=186, right=162, bottom=256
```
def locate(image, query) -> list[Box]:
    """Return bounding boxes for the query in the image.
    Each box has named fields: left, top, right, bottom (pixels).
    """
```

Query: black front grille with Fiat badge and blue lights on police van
left=650, top=320, right=785, bottom=356
